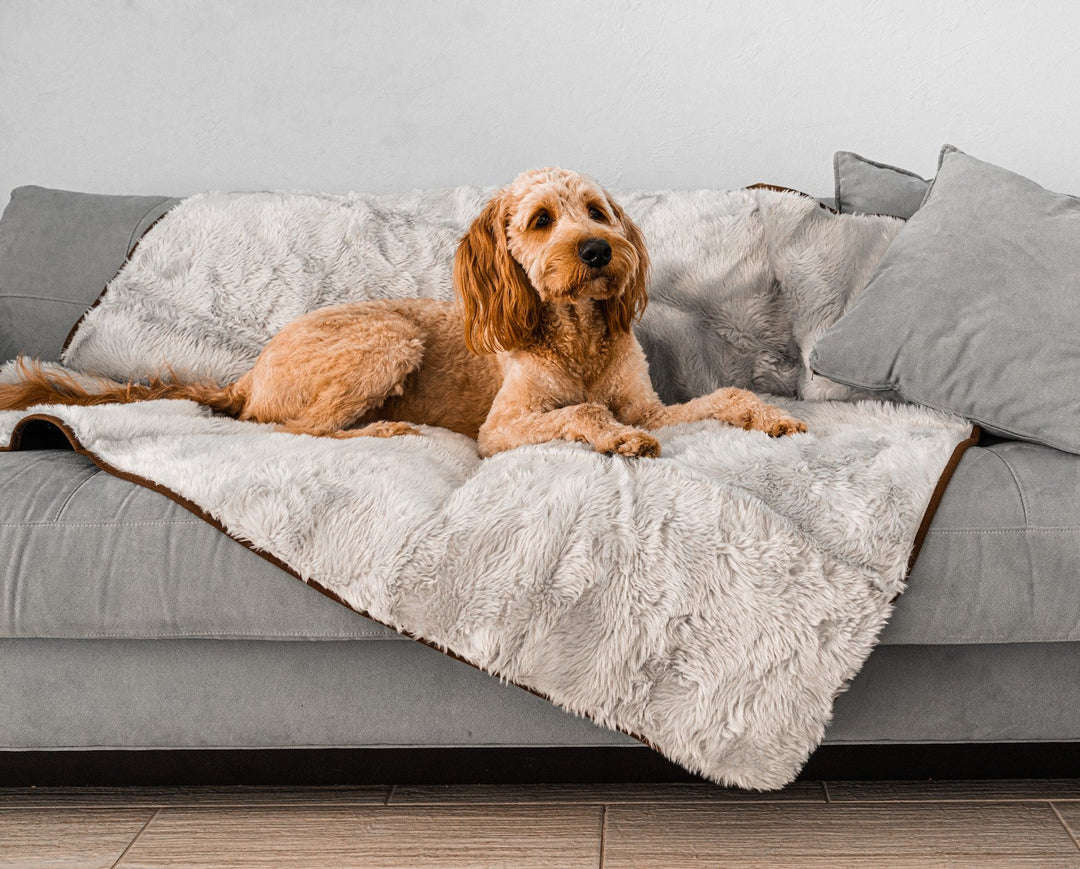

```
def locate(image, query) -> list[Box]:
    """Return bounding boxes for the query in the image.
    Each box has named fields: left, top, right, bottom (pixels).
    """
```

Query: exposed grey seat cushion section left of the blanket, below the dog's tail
left=0, top=449, right=401, bottom=640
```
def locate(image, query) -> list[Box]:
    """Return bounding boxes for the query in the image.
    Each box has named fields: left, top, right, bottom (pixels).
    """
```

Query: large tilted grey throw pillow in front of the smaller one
left=810, top=146, right=1080, bottom=452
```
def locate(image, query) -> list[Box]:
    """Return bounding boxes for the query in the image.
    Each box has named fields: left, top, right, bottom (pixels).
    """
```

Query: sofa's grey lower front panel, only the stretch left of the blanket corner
left=0, top=634, right=636, bottom=750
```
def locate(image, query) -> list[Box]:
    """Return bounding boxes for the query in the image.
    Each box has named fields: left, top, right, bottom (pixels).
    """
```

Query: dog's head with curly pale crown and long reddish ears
left=454, top=168, right=649, bottom=353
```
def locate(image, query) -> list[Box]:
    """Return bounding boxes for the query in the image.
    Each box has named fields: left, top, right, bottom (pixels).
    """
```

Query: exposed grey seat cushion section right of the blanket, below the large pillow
left=881, top=438, right=1080, bottom=644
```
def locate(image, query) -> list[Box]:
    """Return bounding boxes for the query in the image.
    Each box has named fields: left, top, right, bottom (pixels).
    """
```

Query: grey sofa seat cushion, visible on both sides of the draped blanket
left=0, top=431, right=1080, bottom=644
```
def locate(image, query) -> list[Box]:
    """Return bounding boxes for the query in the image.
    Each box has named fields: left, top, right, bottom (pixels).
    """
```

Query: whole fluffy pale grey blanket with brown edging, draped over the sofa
left=0, top=190, right=971, bottom=788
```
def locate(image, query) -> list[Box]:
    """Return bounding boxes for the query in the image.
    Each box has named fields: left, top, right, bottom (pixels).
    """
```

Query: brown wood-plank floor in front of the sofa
left=0, top=779, right=1080, bottom=869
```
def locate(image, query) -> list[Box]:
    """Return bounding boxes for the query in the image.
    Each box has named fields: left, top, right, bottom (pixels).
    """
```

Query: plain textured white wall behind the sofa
left=0, top=0, right=1080, bottom=201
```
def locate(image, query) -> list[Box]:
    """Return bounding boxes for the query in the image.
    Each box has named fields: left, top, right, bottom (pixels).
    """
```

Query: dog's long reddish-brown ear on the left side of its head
left=454, top=194, right=540, bottom=354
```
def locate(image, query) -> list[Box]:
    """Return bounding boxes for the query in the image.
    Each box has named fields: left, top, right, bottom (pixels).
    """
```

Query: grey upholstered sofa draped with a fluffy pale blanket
left=0, top=181, right=1080, bottom=784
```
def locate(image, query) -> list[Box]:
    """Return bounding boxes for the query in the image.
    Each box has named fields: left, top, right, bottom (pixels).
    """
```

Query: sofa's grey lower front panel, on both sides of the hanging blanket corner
left=0, top=639, right=1080, bottom=750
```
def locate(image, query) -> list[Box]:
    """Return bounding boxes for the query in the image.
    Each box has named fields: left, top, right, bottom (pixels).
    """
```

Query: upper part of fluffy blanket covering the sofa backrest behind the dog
left=63, top=187, right=903, bottom=404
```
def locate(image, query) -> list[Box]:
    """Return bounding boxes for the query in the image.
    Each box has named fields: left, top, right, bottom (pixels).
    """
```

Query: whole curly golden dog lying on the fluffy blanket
left=0, top=168, right=806, bottom=456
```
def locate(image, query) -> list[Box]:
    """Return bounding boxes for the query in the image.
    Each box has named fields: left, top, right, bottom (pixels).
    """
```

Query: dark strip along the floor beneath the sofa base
left=0, top=743, right=1080, bottom=787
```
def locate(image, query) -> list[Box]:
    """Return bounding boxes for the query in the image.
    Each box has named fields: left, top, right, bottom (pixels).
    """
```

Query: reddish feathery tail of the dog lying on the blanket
left=0, top=356, right=245, bottom=417
